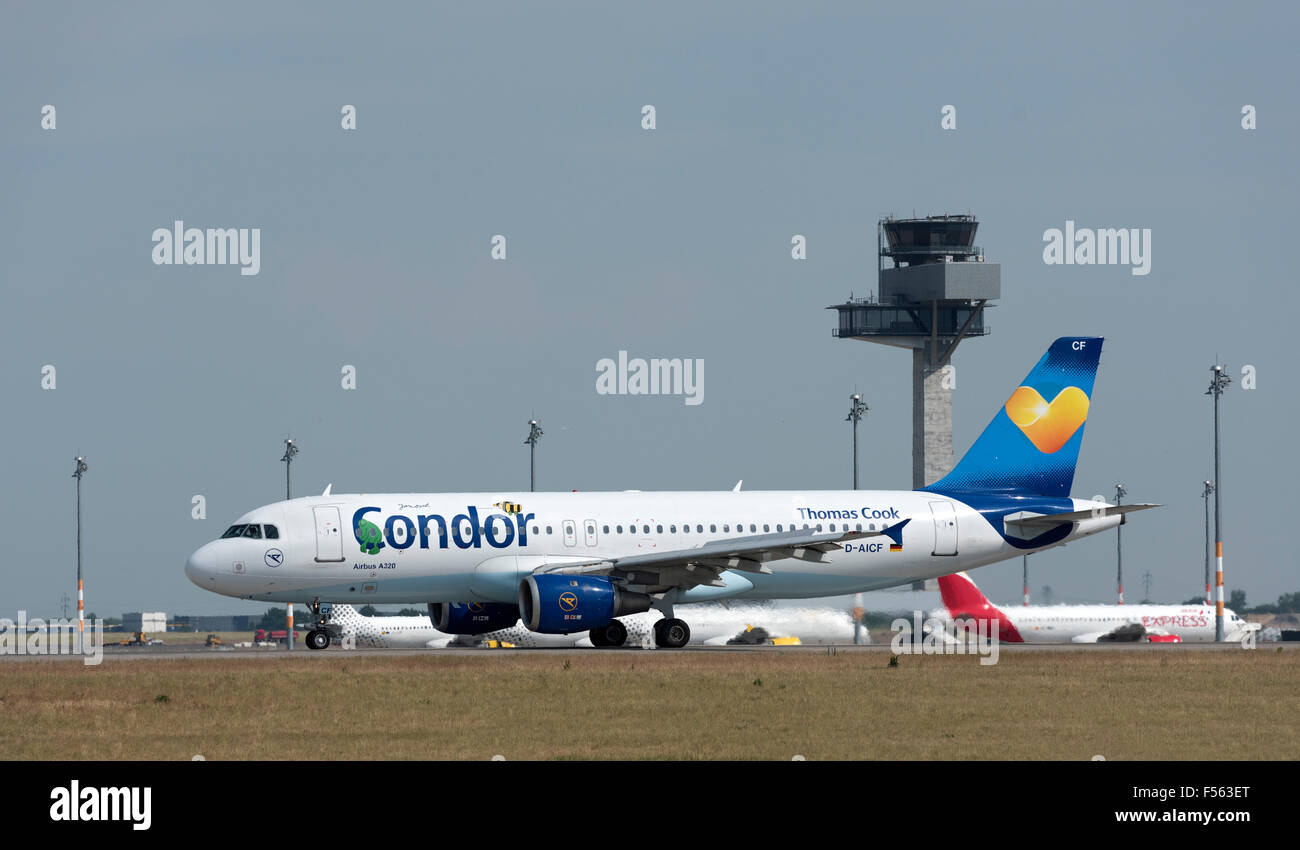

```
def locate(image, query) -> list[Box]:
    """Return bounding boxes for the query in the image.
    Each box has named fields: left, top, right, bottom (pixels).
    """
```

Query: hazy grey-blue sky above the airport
left=0, top=3, right=1300, bottom=616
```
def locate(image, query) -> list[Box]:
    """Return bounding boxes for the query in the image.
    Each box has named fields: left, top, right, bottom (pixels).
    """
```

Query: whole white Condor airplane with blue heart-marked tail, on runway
left=185, top=337, right=1158, bottom=650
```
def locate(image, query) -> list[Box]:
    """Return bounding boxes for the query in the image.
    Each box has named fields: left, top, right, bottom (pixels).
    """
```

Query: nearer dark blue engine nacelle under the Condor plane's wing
left=519, top=576, right=650, bottom=634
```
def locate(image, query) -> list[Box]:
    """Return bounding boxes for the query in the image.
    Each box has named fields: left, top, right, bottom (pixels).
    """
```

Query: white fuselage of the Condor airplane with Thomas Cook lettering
left=186, top=490, right=1121, bottom=606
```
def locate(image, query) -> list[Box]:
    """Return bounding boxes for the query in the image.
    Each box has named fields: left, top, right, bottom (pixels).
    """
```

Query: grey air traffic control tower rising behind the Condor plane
left=827, top=214, right=1002, bottom=487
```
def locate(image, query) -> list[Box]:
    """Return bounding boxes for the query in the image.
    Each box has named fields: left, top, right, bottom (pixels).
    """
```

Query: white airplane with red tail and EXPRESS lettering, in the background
left=939, top=572, right=1260, bottom=643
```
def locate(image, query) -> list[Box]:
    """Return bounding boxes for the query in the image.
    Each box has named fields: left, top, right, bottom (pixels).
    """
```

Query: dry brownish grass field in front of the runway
left=0, top=647, right=1300, bottom=760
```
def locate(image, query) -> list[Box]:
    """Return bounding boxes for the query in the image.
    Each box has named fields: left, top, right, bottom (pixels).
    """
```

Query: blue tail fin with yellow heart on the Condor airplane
left=924, top=337, right=1101, bottom=496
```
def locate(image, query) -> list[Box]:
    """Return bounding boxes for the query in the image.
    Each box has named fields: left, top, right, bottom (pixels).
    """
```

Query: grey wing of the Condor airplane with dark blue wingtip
left=533, top=517, right=911, bottom=589
